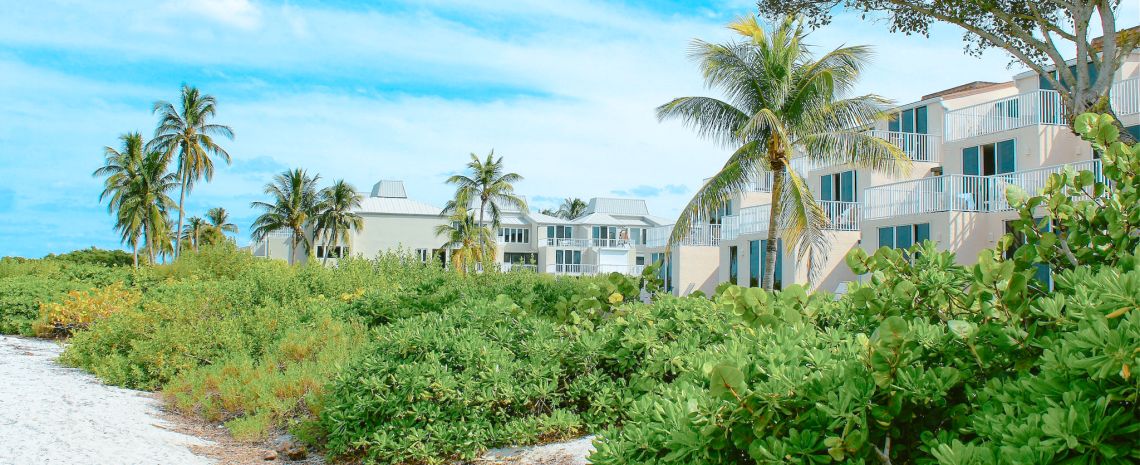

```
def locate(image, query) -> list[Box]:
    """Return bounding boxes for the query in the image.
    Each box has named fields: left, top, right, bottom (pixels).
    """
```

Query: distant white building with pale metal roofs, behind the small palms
left=251, top=181, right=668, bottom=276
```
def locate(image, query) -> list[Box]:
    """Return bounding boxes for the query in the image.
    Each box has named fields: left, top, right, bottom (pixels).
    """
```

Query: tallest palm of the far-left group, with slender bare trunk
left=150, top=84, right=234, bottom=256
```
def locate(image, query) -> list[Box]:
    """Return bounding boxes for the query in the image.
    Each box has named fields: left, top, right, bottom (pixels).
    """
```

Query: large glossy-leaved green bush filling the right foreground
left=591, top=115, right=1140, bottom=465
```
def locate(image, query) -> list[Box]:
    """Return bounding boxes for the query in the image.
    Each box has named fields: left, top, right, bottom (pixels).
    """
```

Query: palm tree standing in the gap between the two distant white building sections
left=443, top=149, right=527, bottom=254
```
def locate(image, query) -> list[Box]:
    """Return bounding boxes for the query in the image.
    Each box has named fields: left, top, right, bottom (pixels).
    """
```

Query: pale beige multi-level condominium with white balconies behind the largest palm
left=665, top=52, right=1140, bottom=292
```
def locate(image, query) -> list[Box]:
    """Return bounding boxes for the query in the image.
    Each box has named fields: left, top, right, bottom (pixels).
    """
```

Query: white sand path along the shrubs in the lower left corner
left=0, top=336, right=213, bottom=465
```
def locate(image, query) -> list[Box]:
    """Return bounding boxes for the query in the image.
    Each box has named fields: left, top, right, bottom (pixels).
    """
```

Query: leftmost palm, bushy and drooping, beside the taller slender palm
left=115, top=152, right=178, bottom=263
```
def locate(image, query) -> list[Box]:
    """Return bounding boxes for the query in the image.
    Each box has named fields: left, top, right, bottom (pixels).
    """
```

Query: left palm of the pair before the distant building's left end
left=250, top=168, right=320, bottom=264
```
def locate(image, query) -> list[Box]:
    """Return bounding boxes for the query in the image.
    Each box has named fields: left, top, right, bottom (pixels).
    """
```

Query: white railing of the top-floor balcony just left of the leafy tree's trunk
left=943, top=90, right=1066, bottom=141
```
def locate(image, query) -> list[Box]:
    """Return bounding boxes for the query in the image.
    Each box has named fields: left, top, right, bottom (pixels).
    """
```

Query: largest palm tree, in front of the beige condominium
left=657, top=18, right=910, bottom=289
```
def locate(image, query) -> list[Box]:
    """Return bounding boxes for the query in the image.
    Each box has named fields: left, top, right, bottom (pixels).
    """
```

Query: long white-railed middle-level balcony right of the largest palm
left=863, top=160, right=1100, bottom=220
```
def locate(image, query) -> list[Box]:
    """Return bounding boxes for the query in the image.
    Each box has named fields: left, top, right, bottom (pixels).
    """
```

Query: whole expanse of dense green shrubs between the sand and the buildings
left=0, top=115, right=1140, bottom=465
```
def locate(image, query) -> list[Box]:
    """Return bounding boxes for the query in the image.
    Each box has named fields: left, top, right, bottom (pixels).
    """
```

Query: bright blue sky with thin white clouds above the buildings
left=0, top=0, right=1140, bottom=256
